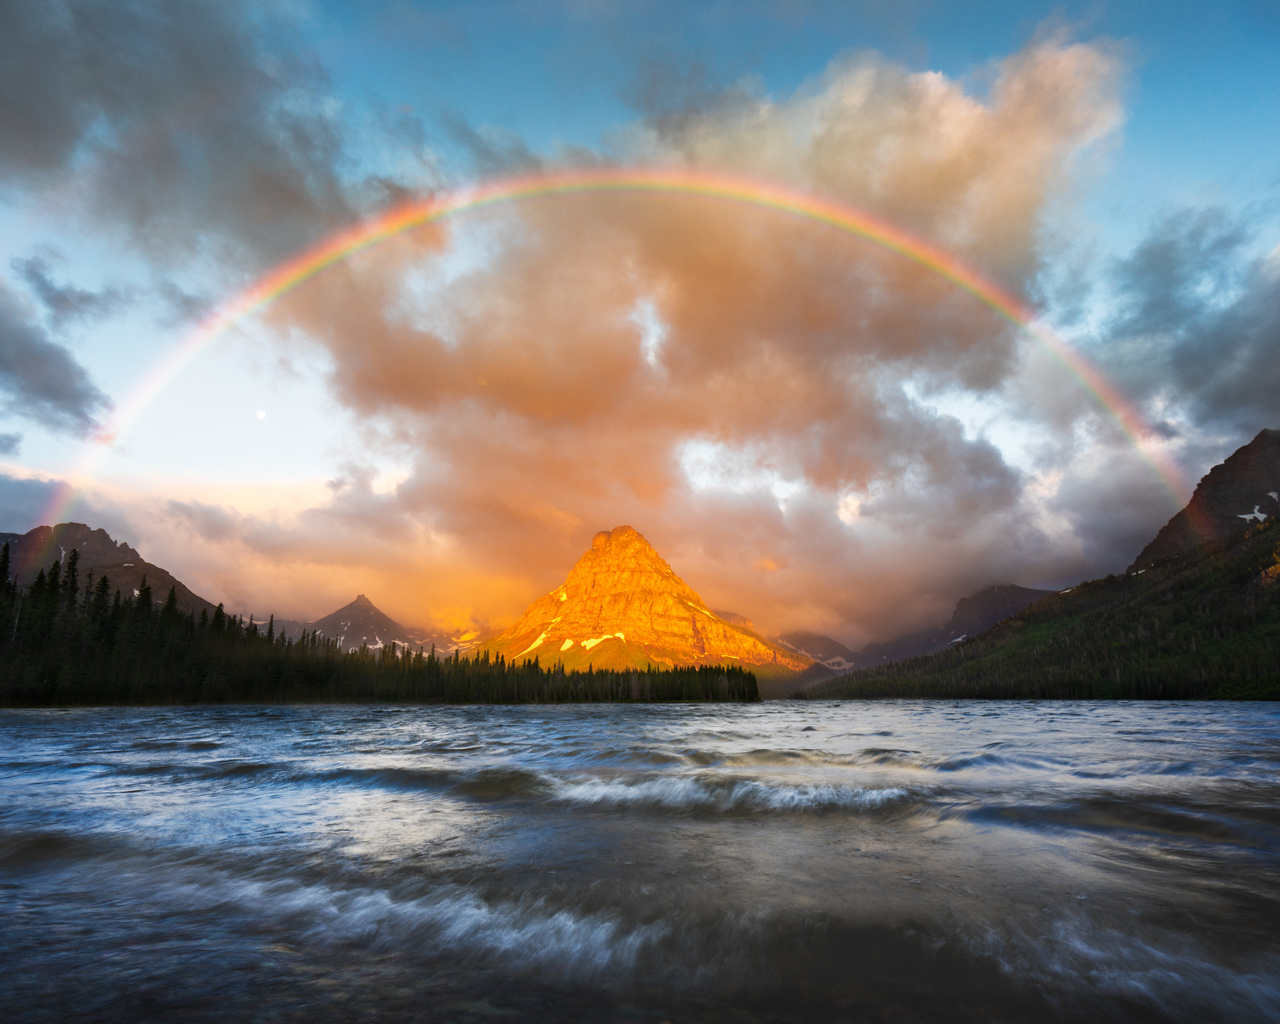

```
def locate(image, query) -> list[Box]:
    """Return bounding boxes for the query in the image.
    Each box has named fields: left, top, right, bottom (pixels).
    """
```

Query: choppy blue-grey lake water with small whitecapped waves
left=0, top=703, right=1280, bottom=1024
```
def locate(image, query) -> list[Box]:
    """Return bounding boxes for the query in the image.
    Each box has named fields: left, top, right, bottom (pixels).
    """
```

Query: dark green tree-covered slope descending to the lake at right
left=800, top=520, right=1280, bottom=700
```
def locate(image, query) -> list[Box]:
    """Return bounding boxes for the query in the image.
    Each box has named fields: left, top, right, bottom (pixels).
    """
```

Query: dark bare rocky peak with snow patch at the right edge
left=1129, top=430, right=1280, bottom=572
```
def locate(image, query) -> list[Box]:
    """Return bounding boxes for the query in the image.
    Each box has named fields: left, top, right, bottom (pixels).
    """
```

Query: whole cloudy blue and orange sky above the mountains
left=0, top=0, right=1280, bottom=645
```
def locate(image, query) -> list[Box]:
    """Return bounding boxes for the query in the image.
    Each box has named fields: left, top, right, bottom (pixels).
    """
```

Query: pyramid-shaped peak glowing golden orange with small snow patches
left=485, top=526, right=812, bottom=676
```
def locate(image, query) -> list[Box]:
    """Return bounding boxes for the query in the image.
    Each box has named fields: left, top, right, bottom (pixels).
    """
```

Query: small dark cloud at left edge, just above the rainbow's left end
left=0, top=282, right=109, bottom=436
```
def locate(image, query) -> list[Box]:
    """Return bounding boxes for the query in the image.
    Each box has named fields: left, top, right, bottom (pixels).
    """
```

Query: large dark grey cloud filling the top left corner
left=0, top=0, right=353, bottom=261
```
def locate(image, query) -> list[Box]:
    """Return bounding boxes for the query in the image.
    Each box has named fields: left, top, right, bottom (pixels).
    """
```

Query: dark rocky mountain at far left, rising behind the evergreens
left=0, top=522, right=214, bottom=614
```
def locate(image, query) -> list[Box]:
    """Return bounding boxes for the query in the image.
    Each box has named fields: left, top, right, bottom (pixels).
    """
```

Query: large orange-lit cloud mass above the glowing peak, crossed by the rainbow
left=204, top=41, right=1132, bottom=640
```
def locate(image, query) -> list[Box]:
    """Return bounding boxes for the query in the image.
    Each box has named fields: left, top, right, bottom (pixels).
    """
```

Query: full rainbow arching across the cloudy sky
left=30, top=168, right=1187, bottom=568
